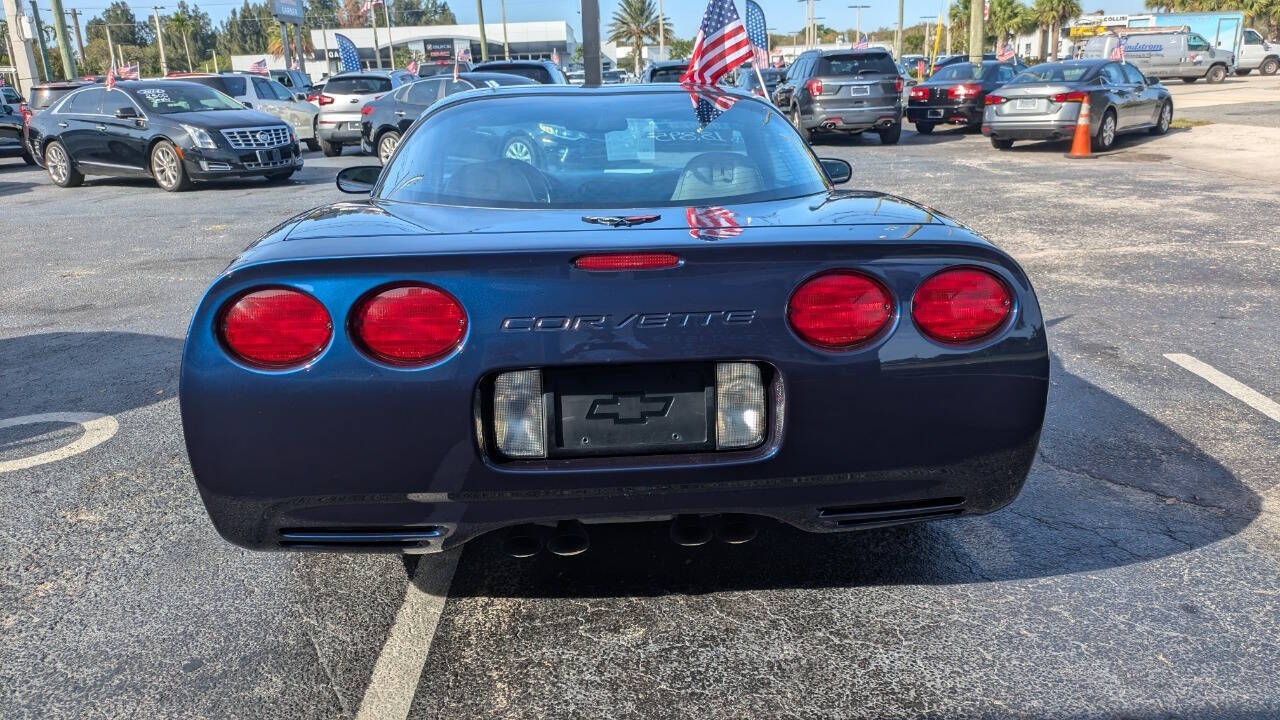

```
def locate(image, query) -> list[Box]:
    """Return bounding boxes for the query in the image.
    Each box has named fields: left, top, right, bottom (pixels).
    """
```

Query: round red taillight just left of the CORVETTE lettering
left=351, top=284, right=467, bottom=365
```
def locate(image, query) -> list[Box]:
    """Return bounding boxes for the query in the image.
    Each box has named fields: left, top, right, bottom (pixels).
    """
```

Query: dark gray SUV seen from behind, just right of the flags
left=773, top=49, right=905, bottom=145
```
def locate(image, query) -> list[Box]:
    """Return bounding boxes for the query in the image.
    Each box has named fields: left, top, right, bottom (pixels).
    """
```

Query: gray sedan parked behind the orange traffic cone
left=982, top=60, right=1174, bottom=151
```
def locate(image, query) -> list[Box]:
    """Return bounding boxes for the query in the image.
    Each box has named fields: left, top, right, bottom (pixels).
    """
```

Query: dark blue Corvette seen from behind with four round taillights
left=182, top=86, right=1048, bottom=555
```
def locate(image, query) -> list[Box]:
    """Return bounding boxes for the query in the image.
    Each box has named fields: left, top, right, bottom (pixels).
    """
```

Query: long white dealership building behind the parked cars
left=307, top=20, right=577, bottom=78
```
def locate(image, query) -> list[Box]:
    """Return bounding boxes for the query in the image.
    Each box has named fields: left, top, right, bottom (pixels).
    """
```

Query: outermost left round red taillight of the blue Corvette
left=219, top=287, right=333, bottom=369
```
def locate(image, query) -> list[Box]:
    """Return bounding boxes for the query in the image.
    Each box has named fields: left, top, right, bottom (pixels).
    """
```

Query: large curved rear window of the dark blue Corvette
left=375, top=92, right=828, bottom=209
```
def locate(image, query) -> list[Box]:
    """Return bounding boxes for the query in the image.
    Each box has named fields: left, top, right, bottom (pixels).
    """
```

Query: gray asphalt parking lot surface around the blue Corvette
left=0, top=77, right=1280, bottom=719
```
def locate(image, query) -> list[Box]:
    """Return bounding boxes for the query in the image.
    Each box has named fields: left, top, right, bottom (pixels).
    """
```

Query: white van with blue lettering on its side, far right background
left=1080, top=31, right=1235, bottom=82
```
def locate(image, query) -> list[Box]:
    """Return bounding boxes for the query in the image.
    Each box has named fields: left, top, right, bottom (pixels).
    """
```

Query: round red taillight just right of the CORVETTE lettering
left=787, top=270, right=893, bottom=348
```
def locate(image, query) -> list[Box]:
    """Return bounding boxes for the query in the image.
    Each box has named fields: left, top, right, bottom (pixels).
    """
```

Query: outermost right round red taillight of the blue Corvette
left=911, top=268, right=1014, bottom=342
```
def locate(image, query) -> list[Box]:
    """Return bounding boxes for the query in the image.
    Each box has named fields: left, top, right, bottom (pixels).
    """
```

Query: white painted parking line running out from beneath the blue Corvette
left=356, top=550, right=462, bottom=720
